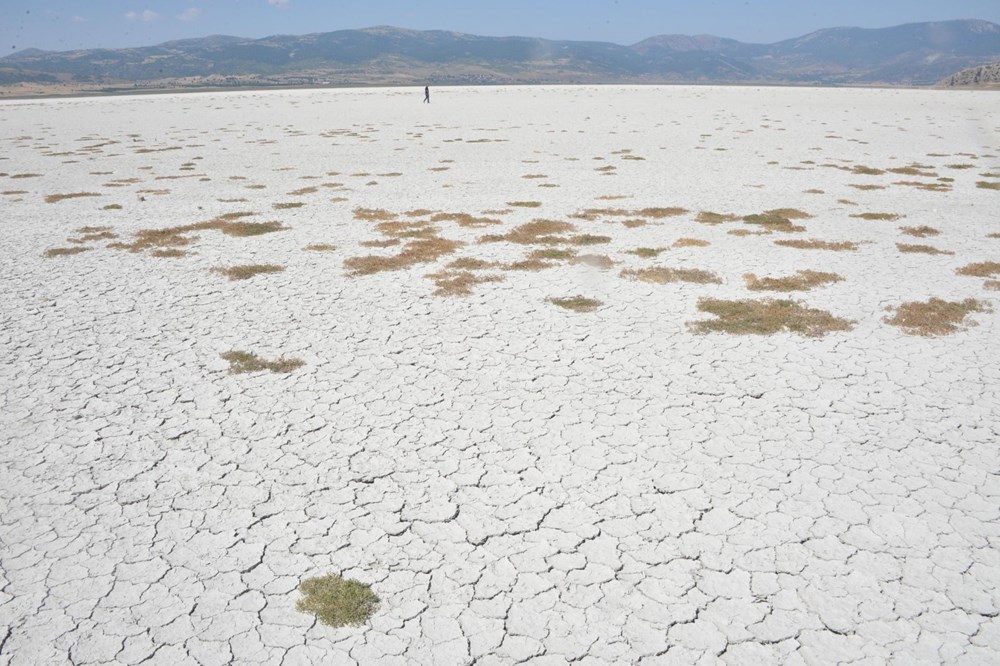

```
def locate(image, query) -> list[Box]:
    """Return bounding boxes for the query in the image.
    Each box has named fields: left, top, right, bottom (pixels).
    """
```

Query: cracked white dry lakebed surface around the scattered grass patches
left=0, top=87, right=1000, bottom=665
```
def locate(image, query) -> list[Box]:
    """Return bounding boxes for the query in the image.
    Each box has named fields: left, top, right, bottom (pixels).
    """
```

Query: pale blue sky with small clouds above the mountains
left=0, top=0, right=1000, bottom=54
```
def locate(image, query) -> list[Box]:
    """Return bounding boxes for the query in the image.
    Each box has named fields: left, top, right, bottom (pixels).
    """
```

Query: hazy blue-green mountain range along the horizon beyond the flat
left=0, top=20, right=1000, bottom=89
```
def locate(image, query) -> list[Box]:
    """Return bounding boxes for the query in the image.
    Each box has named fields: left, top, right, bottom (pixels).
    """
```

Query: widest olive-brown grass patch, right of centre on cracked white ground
left=689, top=298, right=854, bottom=337
